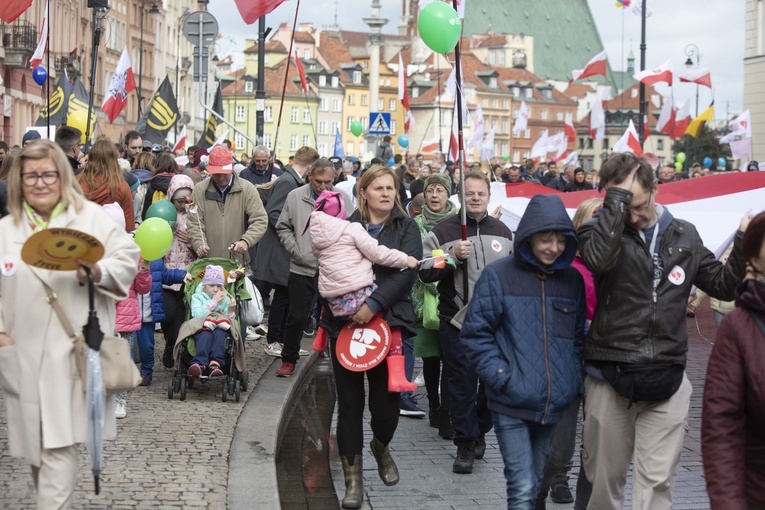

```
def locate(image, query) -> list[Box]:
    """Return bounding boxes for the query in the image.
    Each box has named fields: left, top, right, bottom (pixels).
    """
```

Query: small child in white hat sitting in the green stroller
left=189, top=264, right=236, bottom=379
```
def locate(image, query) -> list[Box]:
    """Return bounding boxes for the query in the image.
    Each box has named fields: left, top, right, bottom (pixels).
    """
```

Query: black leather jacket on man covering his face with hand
left=578, top=188, right=745, bottom=365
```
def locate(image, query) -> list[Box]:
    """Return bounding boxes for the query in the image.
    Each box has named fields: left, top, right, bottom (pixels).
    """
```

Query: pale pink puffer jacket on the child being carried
left=309, top=211, right=407, bottom=298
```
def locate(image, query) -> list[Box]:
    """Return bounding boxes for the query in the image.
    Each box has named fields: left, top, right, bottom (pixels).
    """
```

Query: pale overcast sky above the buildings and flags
left=209, top=0, right=745, bottom=119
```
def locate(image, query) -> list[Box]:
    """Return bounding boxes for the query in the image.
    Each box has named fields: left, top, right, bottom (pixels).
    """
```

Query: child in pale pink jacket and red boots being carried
left=303, top=190, right=419, bottom=392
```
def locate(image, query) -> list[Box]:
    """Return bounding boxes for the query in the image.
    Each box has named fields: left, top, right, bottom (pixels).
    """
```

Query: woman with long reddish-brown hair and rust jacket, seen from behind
left=77, top=140, right=135, bottom=232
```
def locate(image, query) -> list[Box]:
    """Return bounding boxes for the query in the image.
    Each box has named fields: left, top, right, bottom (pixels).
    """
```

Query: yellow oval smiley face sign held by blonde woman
left=21, top=228, right=104, bottom=271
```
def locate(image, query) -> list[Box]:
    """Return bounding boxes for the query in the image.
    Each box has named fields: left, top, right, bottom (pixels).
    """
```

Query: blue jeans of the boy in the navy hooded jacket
left=491, top=411, right=555, bottom=510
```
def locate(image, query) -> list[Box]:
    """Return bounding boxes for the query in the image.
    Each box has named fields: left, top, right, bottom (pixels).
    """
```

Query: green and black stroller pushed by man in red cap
left=167, top=258, right=251, bottom=402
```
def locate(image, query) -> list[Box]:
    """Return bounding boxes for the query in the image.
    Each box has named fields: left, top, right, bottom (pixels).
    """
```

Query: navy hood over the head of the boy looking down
left=513, top=195, right=579, bottom=271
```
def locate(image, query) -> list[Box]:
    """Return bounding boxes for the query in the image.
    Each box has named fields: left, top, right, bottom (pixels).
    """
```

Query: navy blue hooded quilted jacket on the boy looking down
left=460, top=195, right=586, bottom=424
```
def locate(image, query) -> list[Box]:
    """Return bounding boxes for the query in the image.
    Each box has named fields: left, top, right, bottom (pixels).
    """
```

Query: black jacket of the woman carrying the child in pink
left=319, top=209, right=422, bottom=338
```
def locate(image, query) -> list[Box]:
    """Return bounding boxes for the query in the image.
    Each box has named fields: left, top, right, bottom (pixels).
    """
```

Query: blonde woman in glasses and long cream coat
left=0, top=140, right=139, bottom=508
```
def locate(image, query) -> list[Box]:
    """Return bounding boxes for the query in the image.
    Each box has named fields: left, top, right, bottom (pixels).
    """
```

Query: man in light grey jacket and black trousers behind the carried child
left=276, top=158, right=352, bottom=377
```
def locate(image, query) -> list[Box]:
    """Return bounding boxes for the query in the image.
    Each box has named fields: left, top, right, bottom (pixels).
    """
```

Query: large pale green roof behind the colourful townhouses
left=463, top=0, right=616, bottom=86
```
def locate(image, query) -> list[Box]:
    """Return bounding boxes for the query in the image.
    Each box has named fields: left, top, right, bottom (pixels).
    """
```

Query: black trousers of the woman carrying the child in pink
left=330, top=338, right=399, bottom=459
